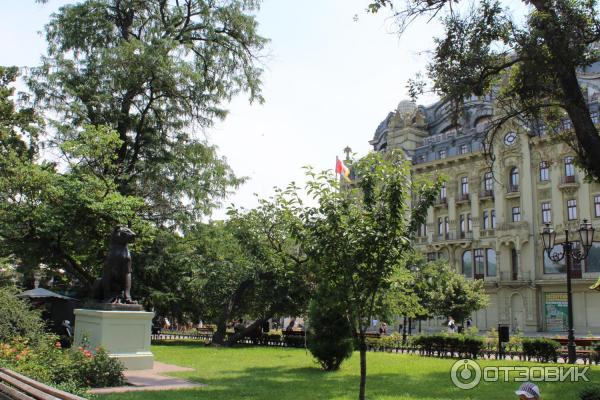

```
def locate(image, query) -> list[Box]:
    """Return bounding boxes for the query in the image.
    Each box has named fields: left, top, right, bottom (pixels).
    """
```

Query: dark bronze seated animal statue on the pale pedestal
left=94, top=226, right=136, bottom=304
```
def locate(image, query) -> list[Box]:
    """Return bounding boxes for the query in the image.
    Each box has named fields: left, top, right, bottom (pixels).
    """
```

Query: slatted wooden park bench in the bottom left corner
left=0, top=368, right=85, bottom=400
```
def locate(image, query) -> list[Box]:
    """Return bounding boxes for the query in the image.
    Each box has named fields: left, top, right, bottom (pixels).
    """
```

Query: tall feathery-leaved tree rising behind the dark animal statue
left=28, top=0, right=266, bottom=227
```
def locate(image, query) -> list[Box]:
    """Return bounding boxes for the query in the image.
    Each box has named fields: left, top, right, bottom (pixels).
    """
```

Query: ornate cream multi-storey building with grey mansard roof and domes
left=370, top=92, right=600, bottom=335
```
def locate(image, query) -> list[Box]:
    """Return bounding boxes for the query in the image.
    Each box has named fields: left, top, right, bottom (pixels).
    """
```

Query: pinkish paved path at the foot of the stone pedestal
left=90, top=361, right=204, bottom=394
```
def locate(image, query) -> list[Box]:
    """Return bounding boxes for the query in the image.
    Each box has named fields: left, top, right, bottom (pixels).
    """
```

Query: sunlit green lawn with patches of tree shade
left=99, top=345, right=600, bottom=400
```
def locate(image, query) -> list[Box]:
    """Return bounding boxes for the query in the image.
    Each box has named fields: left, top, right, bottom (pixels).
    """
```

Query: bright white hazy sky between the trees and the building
left=0, top=0, right=441, bottom=219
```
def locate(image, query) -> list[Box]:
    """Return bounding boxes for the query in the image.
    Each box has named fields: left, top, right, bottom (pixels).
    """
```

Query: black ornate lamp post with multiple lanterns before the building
left=542, top=219, right=594, bottom=364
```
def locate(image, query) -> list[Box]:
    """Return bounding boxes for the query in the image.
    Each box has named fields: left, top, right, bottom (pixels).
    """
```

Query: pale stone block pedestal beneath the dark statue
left=73, top=309, right=154, bottom=370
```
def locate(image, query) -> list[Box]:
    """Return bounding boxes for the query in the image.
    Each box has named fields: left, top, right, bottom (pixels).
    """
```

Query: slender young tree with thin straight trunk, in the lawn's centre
left=297, top=152, right=441, bottom=400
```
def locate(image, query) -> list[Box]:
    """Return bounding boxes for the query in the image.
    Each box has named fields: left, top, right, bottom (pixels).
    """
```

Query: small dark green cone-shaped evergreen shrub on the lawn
left=307, top=285, right=354, bottom=371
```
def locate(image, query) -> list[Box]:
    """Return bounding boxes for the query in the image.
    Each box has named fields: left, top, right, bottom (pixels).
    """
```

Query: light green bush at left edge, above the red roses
left=0, top=287, right=44, bottom=343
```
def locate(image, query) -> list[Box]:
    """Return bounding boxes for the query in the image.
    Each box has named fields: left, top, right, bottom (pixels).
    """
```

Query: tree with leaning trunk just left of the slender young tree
left=223, top=192, right=314, bottom=345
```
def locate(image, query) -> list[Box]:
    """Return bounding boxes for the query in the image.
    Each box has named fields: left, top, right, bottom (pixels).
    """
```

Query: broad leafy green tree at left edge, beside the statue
left=0, top=68, right=146, bottom=286
